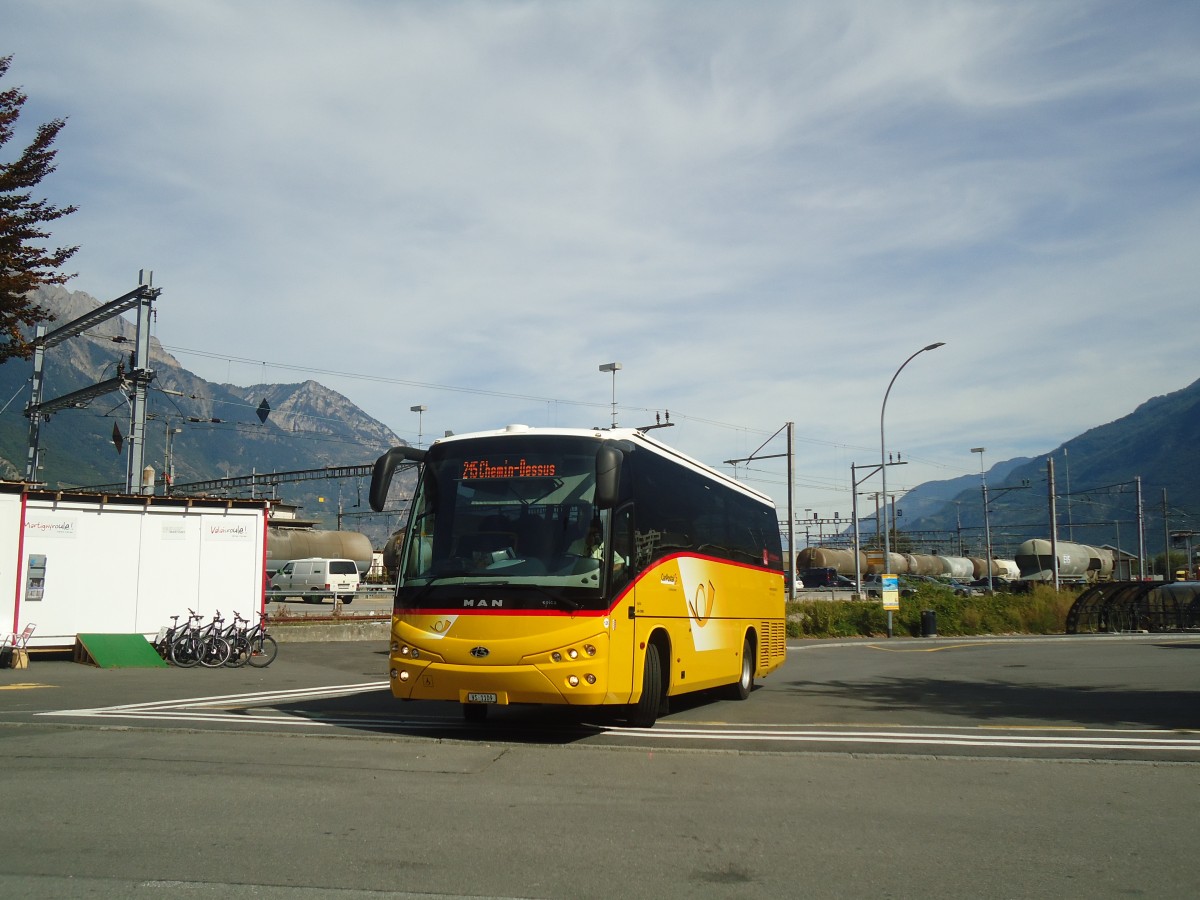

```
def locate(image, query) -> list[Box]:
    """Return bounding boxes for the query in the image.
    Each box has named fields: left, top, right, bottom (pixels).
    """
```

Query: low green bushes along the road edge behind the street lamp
left=787, top=584, right=1076, bottom=637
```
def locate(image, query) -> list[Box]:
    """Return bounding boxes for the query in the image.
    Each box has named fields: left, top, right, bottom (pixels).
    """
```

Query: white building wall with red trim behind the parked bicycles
left=0, top=493, right=266, bottom=647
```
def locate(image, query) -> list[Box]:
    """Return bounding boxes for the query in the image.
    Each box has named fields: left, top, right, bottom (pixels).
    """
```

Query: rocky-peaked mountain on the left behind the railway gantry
left=0, top=287, right=404, bottom=547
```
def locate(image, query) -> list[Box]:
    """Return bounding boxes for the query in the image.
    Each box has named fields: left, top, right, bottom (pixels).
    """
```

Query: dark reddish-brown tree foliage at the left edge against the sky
left=0, top=56, right=78, bottom=362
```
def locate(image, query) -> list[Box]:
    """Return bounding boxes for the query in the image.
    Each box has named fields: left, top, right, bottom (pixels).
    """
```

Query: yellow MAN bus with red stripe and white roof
left=371, top=425, right=786, bottom=727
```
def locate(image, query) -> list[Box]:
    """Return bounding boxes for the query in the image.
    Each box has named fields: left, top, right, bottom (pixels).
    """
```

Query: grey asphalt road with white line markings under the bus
left=0, top=637, right=1200, bottom=898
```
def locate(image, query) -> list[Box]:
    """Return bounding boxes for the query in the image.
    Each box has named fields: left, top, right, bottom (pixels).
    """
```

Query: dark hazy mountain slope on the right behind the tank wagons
left=883, top=380, right=1200, bottom=557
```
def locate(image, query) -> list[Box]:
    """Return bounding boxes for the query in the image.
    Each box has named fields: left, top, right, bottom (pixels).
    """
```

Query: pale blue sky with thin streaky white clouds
left=0, top=0, right=1200, bottom=517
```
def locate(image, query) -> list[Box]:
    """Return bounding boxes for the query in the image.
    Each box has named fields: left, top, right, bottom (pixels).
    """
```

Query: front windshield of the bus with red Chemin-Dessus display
left=396, top=434, right=608, bottom=610
